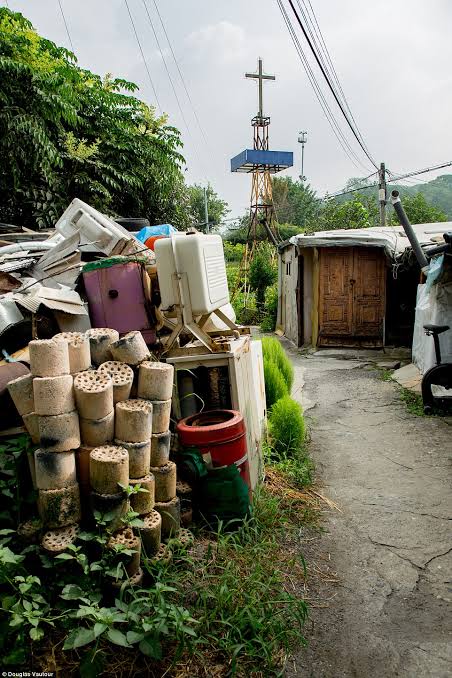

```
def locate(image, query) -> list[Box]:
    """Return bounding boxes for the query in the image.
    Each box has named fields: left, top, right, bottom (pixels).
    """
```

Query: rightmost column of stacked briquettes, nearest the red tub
left=138, top=361, right=180, bottom=537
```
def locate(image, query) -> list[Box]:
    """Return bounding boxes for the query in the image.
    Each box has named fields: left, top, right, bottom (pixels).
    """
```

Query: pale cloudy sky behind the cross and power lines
left=4, top=0, right=452, bottom=216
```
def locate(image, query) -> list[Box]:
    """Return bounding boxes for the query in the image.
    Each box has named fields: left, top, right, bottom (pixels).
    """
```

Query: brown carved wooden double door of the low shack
left=318, top=247, right=385, bottom=346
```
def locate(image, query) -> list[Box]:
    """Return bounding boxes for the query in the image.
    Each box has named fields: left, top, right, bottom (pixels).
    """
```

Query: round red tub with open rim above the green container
left=177, top=410, right=251, bottom=495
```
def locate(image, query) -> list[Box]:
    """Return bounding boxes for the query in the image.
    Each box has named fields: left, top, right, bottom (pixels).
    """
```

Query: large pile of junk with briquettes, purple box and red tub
left=0, top=199, right=266, bottom=581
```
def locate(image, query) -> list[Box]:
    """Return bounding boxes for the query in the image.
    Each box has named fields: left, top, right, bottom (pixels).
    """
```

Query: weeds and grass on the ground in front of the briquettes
left=0, top=436, right=307, bottom=676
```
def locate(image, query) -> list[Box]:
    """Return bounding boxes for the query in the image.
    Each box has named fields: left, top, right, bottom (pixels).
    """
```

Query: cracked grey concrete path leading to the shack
left=286, top=349, right=452, bottom=678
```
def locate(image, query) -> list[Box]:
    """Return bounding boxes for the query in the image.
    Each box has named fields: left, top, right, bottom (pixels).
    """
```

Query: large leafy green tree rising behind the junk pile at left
left=0, top=8, right=190, bottom=228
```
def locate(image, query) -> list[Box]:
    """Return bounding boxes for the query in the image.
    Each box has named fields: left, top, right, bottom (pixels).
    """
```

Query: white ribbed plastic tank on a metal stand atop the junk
left=155, top=233, right=229, bottom=315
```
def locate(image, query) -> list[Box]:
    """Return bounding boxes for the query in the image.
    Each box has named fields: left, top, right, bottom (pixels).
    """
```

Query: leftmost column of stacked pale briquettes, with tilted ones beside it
left=8, top=333, right=85, bottom=553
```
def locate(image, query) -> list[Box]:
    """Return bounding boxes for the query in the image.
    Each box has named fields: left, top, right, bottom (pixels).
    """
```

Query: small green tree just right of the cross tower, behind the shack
left=272, top=177, right=320, bottom=231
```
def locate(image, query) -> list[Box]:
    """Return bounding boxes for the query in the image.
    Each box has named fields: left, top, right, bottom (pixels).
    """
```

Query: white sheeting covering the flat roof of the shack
left=289, top=221, right=452, bottom=259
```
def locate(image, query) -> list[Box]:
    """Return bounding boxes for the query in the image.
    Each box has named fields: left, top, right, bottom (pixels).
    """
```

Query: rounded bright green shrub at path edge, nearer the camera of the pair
left=268, top=395, right=305, bottom=456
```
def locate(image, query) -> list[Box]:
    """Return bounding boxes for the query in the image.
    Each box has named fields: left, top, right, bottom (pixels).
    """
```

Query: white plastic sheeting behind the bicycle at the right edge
left=413, top=283, right=452, bottom=374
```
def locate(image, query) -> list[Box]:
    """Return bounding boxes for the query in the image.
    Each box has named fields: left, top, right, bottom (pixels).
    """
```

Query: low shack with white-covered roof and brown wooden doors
left=277, top=222, right=452, bottom=348
